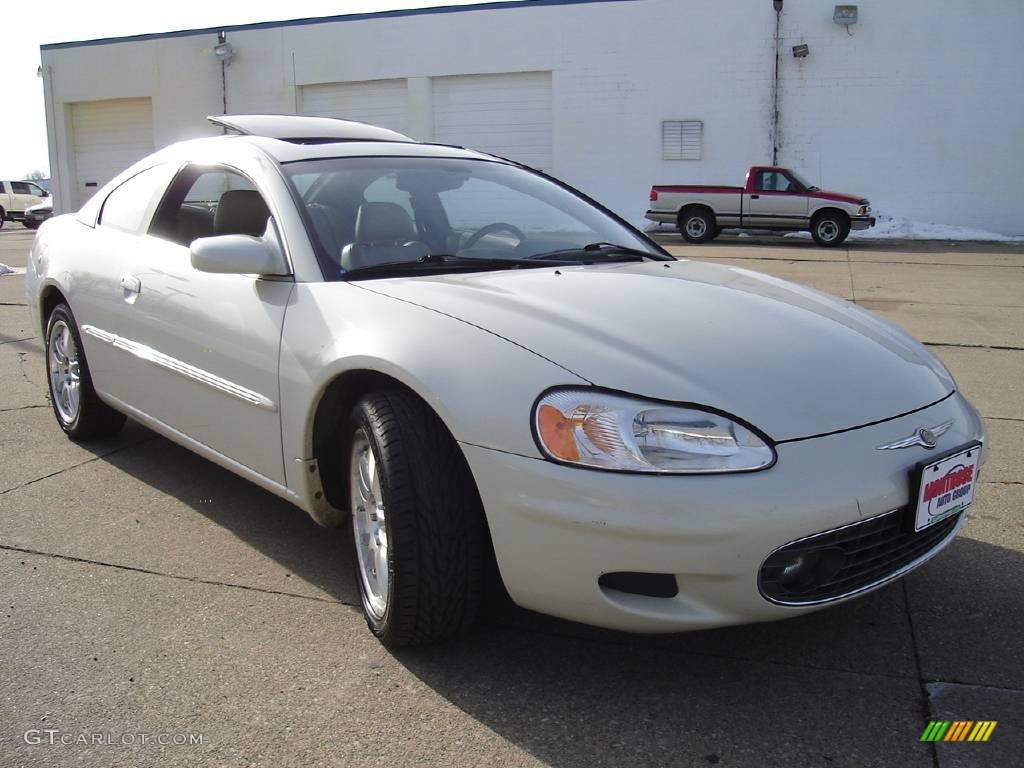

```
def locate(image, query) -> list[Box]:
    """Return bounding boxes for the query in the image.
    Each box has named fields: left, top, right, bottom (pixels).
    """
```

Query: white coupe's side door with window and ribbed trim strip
left=117, top=165, right=294, bottom=483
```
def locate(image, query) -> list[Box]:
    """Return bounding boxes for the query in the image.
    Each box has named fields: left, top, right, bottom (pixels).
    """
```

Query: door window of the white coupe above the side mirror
left=150, top=166, right=270, bottom=248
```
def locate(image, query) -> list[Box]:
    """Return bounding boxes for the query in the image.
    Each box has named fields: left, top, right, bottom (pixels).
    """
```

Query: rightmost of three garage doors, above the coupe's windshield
left=433, top=72, right=552, bottom=171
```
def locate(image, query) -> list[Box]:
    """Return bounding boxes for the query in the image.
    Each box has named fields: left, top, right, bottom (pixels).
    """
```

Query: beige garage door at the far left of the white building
left=71, top=98, right=153, bottom=210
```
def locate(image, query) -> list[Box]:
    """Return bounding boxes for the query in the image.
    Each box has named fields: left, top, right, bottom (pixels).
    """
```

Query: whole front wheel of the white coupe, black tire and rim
left=348, top=390, right=485, bottom=647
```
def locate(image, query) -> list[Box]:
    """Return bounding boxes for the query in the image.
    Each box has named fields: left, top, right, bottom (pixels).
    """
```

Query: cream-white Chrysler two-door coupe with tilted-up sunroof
left=26, top=116, right=983, bottom=645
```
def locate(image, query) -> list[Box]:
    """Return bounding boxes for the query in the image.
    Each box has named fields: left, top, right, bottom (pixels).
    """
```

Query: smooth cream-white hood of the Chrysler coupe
left=356, top=261, right=954, bottom=440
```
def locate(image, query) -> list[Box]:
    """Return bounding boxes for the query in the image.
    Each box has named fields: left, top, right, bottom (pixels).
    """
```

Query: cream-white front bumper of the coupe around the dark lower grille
left=463, top=394, right=983, bottom=633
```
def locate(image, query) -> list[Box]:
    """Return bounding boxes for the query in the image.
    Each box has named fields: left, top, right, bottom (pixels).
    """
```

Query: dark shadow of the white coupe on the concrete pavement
left=86, top=425, right=1024, bottom=768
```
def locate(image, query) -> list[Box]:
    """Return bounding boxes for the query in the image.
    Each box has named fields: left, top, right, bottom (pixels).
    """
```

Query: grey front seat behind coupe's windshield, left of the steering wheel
left=341, top=203, right=430, bottom=270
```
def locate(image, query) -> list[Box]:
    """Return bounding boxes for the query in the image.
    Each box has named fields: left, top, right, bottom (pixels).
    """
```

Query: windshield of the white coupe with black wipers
left=284, top=157, right=664, bottom=279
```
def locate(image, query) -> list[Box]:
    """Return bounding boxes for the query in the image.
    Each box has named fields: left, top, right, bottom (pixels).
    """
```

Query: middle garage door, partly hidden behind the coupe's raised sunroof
left=302, top=80, right=409, bottom=133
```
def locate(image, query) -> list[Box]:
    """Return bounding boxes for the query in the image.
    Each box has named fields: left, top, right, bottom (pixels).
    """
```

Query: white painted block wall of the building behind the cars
left=43, top=0, right=1024, bottom=234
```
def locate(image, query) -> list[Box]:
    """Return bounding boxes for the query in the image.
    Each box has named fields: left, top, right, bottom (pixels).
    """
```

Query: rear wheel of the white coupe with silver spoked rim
left=46, top=304, right=125, bottom=441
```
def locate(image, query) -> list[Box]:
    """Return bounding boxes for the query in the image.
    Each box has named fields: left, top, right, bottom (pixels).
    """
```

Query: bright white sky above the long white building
left=0, top=0, right=507, bottom=179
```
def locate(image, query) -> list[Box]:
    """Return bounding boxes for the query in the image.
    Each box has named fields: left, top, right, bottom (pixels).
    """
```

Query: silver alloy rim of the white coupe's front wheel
left=348, top=429, right=390, bottom=620
